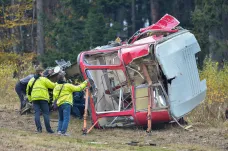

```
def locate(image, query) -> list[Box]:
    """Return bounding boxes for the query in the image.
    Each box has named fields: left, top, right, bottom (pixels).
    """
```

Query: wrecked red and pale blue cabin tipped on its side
left=78, top=14, right=206, bottom=128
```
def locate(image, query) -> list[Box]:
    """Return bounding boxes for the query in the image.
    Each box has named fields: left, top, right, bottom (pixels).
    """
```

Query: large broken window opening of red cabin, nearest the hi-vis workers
left=86, top=70, right=132, bottom=113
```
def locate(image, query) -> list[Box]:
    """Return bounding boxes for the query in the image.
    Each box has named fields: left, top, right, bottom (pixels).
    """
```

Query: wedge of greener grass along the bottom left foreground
left=0, top=128, right=173, bottom=151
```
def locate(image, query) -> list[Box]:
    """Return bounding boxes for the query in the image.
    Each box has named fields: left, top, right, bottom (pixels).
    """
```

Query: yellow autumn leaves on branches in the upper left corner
left=0, top=0, right=36, bottom=51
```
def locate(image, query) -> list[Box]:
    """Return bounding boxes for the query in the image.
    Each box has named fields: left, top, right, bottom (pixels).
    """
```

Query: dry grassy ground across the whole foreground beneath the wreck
left=0, top=108, right=228, bottom=151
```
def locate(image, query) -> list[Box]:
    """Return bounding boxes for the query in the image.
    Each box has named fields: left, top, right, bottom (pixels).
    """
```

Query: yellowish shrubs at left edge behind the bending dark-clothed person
left=0, top=53, right=34, bottom=108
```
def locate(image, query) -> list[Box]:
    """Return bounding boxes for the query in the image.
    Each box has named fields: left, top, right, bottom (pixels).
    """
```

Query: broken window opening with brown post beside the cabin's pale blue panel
left=126, top=56, right=168, bottom=111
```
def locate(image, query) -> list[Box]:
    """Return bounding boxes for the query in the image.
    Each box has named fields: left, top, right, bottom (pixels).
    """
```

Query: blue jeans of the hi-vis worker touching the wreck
left=58, top=103, right=71, bottom=134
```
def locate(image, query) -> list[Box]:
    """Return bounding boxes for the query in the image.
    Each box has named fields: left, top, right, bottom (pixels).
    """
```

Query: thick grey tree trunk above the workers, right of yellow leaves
left=36, top=0, right=44, bottom=55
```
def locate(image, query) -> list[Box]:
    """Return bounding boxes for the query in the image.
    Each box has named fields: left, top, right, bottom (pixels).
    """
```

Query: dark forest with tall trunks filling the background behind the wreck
left=0, top=0, right=228, bottom=66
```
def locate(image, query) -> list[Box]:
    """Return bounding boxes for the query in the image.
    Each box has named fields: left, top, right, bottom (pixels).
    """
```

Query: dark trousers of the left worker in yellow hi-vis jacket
left=33, top=100, right=52, bottom=132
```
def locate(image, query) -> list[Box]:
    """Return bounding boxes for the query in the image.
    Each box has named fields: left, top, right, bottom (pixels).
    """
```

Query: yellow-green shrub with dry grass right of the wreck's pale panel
left=187, top=58, right=228, bottom=126
